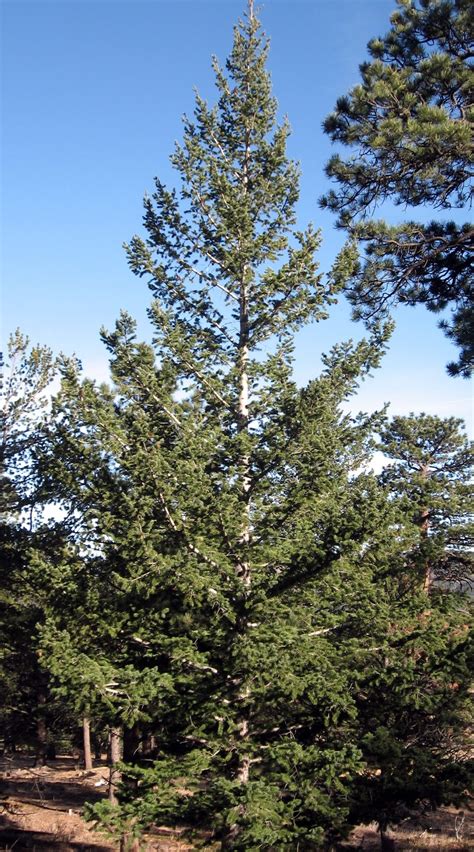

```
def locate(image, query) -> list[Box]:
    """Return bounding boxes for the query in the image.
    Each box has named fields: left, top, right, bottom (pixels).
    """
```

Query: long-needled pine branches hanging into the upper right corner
left=321, top=0, right=474, bottom=376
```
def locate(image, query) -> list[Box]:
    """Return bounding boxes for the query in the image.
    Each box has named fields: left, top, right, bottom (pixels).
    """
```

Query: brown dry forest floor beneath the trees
left=0, top=756, right=474, bottom=852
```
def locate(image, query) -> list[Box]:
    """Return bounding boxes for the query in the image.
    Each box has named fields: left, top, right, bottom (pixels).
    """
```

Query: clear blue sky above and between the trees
left=1, top=0, right=470, bottom=432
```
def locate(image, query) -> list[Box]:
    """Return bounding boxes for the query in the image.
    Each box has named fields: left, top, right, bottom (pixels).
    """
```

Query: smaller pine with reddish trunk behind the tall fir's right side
left=353, top=415, right=474, bottom=836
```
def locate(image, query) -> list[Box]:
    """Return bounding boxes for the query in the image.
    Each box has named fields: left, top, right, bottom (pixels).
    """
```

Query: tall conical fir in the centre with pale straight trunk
left=39, top=5, right=470, bottom=850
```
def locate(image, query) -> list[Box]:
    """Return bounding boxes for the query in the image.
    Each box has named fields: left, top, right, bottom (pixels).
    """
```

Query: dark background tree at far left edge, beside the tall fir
left=0, top=330, right=58, bottom=760
